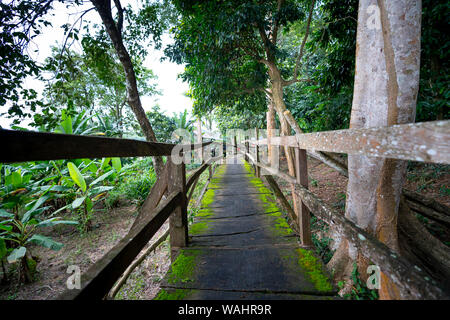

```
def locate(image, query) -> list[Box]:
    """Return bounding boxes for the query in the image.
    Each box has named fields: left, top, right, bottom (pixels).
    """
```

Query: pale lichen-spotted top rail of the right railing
left=244, top=120, right=450, bottom=164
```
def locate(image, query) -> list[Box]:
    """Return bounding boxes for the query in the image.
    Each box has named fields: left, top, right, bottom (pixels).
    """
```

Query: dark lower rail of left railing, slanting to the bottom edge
left=57, top=191, right=183, bottom=300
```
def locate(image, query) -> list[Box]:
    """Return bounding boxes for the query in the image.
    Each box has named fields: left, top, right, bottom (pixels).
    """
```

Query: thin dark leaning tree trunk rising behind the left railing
left=91, top=0, right=164, bottom=175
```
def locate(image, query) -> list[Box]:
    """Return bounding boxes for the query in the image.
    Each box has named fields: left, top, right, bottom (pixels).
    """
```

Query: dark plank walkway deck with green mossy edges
left=156, top=159, right=336, bottom=300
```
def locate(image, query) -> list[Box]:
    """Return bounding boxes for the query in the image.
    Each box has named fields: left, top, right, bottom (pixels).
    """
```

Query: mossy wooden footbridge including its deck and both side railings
left=0, top=121, right=450, bottom=299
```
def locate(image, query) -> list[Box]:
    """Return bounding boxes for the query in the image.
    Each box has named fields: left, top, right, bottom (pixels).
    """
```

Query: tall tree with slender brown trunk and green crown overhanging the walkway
left=166, top=0, right=316, bottom=224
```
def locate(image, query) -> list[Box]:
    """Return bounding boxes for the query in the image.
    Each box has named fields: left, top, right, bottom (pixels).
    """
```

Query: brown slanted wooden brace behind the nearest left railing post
left=129, top=163, right=168, bottom=233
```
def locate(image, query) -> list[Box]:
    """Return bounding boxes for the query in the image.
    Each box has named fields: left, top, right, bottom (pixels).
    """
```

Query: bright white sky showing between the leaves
left=0, top=0, right=192, bottom=128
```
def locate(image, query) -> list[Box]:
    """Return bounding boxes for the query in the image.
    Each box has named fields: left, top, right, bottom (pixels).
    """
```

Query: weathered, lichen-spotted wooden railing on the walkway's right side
left=234, top=121, right=450, bottom=299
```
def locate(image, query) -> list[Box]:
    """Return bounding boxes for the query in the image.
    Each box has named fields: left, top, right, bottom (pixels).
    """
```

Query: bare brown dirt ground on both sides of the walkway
left=0, top=158, right=450, bottom=300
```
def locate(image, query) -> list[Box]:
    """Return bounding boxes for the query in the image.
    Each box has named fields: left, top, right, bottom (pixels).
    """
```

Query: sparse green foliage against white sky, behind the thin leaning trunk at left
left=37, top=38, right=159, bottom=137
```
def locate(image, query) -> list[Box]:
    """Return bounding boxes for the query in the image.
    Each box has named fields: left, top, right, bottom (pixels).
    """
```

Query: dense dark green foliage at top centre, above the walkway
left=165, top=1, right=301, bottom=115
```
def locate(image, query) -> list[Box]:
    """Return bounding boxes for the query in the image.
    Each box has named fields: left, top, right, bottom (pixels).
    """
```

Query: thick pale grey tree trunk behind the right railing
left=329, top=0, right=421, bottom=299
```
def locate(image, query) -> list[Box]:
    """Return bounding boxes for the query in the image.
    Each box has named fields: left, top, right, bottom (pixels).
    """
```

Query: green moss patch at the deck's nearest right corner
left=297, top=248, right=333, bottom=292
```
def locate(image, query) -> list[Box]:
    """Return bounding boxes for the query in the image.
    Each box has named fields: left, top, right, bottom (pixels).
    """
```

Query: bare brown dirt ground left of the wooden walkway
left=0, top=203, right=170, bottom=300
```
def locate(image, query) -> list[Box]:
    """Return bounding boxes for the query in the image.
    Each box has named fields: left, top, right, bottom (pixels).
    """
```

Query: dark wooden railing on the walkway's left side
left=0, top=130, right=222, bottom=299
